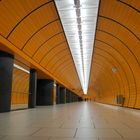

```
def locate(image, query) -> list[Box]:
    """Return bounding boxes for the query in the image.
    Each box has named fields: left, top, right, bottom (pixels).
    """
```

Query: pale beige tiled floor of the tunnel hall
left=0, top=102, right=140, bottom=140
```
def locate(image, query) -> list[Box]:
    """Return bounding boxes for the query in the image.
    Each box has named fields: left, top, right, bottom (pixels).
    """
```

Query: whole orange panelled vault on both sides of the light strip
left=0, top=0, right=140, bottom=99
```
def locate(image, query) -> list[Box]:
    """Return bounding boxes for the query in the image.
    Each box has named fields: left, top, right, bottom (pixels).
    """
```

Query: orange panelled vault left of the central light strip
left=0, top=0, right=81, bottom=94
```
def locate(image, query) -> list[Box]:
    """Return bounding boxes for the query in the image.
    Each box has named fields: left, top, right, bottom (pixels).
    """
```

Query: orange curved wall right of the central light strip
left=90, top=0, right=140, bottom=109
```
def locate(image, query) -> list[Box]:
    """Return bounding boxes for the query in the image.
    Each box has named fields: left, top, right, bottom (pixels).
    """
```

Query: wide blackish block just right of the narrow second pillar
left=36, top=79, right=54, bottom=105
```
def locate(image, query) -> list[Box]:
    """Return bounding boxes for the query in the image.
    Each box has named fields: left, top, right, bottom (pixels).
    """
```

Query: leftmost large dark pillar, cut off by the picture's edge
left=0, top=51, right=14, bottom=112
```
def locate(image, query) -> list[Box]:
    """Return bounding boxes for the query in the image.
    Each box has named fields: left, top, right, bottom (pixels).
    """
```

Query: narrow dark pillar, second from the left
left=28, top=69, right=37, bottom=108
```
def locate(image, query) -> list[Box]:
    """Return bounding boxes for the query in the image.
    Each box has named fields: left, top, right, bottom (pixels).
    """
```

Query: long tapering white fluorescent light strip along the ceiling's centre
left=55, top=0, right=99, bottom=94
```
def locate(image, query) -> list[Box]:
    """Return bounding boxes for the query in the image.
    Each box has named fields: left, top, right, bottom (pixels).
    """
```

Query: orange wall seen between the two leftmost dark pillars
left=11, top=68, right=29, bottom=108
